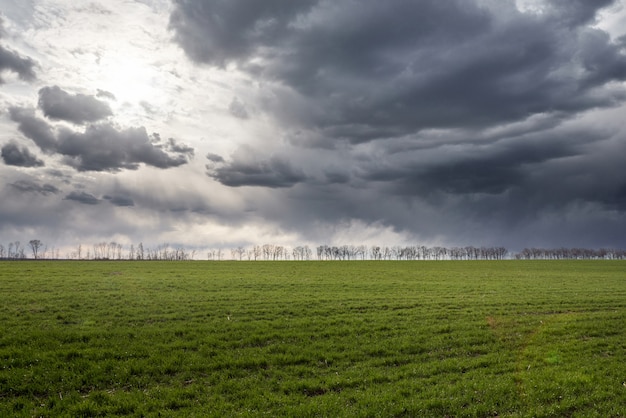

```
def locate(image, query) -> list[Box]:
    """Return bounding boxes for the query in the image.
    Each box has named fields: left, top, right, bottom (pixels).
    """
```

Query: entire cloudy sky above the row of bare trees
left=0, top=0, right=626, bottom=255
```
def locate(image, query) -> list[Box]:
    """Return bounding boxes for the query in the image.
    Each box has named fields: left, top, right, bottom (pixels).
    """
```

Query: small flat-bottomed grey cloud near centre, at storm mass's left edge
left=207, top=146, right=306, bottom=188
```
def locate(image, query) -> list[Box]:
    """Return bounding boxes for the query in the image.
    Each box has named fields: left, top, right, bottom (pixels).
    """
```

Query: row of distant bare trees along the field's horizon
left=0, top=239, right=626, bottom=261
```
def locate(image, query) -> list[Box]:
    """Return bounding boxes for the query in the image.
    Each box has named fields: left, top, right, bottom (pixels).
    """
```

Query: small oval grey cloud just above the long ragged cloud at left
left=39, top=86, right=113, bottom=125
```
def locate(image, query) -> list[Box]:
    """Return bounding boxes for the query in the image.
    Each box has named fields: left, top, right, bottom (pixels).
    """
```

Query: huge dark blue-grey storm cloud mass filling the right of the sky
left=165, top=0, right=626, bottom=245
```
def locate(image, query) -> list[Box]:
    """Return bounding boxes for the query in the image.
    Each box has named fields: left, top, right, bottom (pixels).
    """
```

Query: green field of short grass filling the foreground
left=0, top=261, right=626, bottom=417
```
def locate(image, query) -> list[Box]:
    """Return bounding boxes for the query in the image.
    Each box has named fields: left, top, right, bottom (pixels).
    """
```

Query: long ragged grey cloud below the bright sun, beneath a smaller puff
left=9, top=107, right=193, bottom=172
